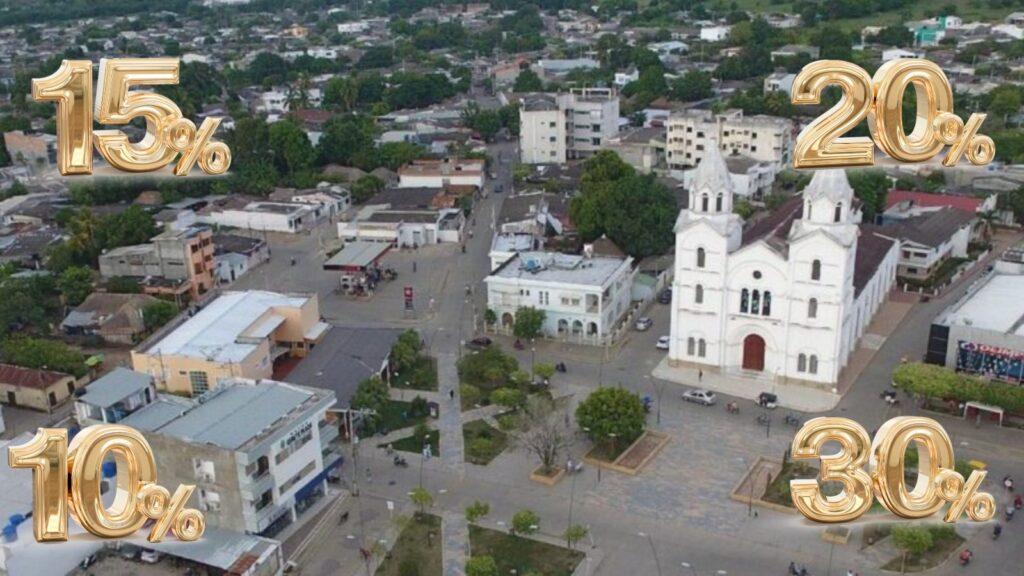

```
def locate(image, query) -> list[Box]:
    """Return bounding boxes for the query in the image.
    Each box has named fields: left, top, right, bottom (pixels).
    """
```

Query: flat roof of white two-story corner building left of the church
left=487, top=251, right=633, bottom=287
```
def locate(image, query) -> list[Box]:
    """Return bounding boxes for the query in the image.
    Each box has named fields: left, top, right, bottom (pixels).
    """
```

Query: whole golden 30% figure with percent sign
left=790, top=416, right=995, bottom=523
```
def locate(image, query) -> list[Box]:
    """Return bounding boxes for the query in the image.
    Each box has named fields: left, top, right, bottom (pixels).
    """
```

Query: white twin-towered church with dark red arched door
left=668, top=146, right=899, bottom=393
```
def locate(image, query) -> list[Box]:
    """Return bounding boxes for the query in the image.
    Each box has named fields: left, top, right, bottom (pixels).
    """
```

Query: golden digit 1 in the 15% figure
left=32, top=60, right=92, bottom=174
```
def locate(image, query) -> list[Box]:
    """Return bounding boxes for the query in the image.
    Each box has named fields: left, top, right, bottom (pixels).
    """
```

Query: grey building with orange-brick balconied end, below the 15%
left=99, top=225, right=216, bottom=298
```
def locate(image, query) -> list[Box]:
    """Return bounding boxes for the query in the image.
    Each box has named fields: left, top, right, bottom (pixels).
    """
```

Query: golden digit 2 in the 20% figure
left=792, top=60, right=874, bottom=168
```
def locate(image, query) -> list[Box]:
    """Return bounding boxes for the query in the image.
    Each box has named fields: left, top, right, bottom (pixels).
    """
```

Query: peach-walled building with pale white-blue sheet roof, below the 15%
left=131, top=290, right=330, bottom=396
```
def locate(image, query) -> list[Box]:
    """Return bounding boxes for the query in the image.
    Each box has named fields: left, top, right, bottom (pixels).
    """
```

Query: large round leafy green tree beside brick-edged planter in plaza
left=575, top=386, right=646, bottom=449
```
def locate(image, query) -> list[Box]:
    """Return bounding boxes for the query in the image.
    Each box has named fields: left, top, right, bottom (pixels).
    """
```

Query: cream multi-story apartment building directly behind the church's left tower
left=665, top=110, right=793, bottom=170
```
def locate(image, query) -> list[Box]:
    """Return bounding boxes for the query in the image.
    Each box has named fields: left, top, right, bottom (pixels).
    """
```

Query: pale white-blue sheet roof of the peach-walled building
left=142, top=290, right=310, bottom=362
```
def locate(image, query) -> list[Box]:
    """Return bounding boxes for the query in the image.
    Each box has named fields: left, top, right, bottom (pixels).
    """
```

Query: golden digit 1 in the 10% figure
left=7, top=428, right=68, bottom=542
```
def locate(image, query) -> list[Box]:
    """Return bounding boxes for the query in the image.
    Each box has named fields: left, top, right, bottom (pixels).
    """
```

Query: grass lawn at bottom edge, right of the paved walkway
left=469, top=526, right=585, bottom=576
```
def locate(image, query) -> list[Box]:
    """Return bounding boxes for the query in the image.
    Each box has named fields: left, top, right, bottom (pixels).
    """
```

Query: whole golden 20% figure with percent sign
left=792, top=58, right=995, bottom=168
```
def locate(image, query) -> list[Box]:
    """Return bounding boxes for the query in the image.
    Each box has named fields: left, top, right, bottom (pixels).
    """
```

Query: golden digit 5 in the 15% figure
left=93, top=58, right=181, bottom=172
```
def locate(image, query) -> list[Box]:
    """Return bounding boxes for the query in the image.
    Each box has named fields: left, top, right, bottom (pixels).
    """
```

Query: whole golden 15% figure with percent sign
left=32, top=58, right=231, bottom=176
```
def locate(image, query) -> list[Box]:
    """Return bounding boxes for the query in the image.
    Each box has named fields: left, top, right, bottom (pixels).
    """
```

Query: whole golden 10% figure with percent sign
left=7, top=424, right=206, bottom=542
